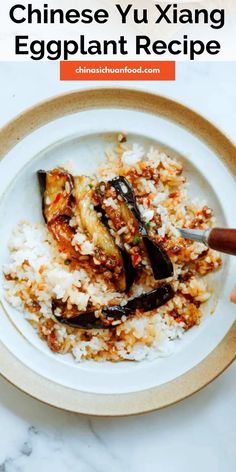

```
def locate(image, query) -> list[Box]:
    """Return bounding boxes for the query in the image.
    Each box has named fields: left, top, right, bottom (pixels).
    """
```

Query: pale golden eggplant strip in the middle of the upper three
left=74, top=176, right=126, bottom=292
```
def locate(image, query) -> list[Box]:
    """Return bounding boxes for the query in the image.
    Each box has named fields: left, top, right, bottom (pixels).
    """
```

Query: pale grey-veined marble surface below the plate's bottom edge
left=0, top=366, right=236, bottom=472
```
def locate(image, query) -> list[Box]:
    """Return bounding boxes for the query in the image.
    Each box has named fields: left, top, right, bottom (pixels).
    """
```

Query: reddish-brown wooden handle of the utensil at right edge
left=208, top=228, right=236, bottom=256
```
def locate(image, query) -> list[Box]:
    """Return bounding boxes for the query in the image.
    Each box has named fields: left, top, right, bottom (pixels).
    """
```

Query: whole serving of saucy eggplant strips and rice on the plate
left=3, top=135, right=222, bottom=361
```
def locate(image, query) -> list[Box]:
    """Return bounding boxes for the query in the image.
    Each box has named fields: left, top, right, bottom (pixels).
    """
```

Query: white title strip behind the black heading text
left=0, top=0, right=236, bottom=62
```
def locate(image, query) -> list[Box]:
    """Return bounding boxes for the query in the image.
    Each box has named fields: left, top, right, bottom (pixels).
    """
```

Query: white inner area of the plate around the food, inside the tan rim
left=0, top=88, right=236, bottom=413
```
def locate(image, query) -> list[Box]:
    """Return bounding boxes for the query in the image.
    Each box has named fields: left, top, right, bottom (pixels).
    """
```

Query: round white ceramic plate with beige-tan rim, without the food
left=0, top=88, right=236, bottom=416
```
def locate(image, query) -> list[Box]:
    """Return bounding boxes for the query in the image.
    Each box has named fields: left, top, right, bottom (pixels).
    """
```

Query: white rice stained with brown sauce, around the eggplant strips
left=3, top=135, right=221, bottom=361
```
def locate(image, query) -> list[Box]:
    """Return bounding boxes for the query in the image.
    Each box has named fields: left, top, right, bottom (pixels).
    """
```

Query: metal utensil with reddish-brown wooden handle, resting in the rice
left=178, top=228, right=236, bottom=256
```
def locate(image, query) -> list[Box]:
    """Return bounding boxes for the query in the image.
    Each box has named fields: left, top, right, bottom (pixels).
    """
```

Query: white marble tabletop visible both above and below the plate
left=0, top=63, right=236, bottom=472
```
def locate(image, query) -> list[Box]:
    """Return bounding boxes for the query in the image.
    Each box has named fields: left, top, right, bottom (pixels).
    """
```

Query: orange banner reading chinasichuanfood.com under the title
left=60, top=61, right=175, bottom=80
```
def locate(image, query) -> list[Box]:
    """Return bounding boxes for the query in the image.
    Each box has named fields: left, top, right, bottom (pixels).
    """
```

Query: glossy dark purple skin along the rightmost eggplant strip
left=109, top=176, right=174, bottom=280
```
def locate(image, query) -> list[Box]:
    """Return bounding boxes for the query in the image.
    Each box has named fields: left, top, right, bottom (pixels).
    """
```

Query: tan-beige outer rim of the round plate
left=0, top=87, right=236, bottom=416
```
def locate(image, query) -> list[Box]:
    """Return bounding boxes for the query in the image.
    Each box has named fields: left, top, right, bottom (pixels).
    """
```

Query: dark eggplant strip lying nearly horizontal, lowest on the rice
left=52, top=284, right=175, bottom=329
